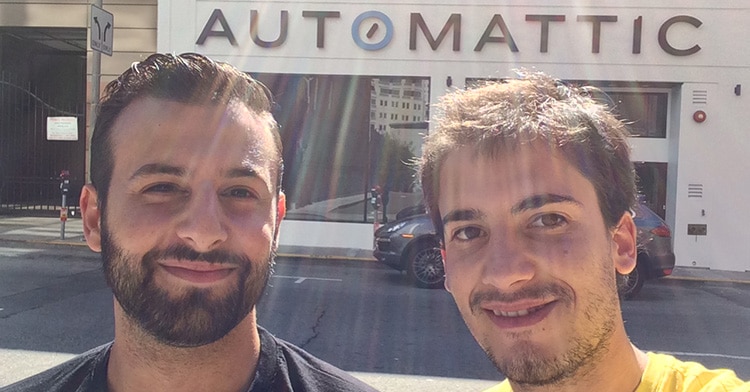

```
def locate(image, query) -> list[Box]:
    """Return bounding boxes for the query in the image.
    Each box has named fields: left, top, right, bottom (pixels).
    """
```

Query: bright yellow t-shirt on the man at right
left=485, top=353, right=750, bottom=392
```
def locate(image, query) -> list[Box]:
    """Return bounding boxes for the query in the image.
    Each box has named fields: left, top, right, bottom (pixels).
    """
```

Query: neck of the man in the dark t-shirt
left=107, top=301, right=260, bottom=392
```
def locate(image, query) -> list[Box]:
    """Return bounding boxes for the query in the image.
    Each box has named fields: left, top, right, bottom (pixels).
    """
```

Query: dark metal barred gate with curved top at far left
left=0, top=71, right=86, bottom=215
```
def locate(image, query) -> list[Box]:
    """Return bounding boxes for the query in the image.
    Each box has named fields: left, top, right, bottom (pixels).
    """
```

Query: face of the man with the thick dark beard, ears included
left=82, top=98, right=284, bottom=346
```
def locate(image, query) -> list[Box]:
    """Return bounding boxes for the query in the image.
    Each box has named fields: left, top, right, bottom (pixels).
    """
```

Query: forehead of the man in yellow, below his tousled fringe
left=438, top=144, right=598, bottom=214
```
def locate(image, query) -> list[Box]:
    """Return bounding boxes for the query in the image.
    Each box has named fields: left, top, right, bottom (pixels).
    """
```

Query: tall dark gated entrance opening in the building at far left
left=0, top=27, right=86, bottom=214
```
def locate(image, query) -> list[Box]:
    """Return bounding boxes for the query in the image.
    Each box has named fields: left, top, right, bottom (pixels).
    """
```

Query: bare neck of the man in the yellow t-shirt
left=510, top=326, right=648, bottom=392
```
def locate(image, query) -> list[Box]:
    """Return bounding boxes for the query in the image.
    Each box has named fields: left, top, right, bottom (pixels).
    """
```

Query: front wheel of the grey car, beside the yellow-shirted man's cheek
left=406, top=242, right=445, bottom=289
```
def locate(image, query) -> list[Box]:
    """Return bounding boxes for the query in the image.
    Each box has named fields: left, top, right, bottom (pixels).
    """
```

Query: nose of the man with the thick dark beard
left=177, top=187, right=228, bottom=252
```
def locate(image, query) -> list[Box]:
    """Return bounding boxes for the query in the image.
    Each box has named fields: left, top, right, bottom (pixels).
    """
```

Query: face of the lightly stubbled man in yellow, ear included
left=438, top=145, right=635, bottom=385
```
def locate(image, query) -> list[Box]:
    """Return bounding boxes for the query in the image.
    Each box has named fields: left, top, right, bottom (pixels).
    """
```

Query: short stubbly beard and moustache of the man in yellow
left=471, top=263, right=619, bottom=386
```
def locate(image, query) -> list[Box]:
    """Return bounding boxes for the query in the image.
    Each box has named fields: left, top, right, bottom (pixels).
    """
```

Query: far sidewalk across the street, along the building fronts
left=0, top=215, right=750, bottom=284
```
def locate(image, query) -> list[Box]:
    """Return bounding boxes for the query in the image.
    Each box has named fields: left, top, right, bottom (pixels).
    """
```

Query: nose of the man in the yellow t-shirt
left=482, top=236, right=537, bottom=291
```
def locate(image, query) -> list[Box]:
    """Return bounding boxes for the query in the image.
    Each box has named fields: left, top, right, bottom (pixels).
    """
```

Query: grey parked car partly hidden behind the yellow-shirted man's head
left=373, top=204, right=675, bottom=299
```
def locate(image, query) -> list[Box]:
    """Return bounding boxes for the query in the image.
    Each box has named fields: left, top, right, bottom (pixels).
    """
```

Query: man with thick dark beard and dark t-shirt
left=4, top=54, right=373, bottom=392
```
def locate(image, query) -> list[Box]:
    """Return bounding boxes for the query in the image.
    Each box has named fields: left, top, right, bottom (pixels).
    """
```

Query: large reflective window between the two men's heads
left=253, top=74, right=430, bottom=222
